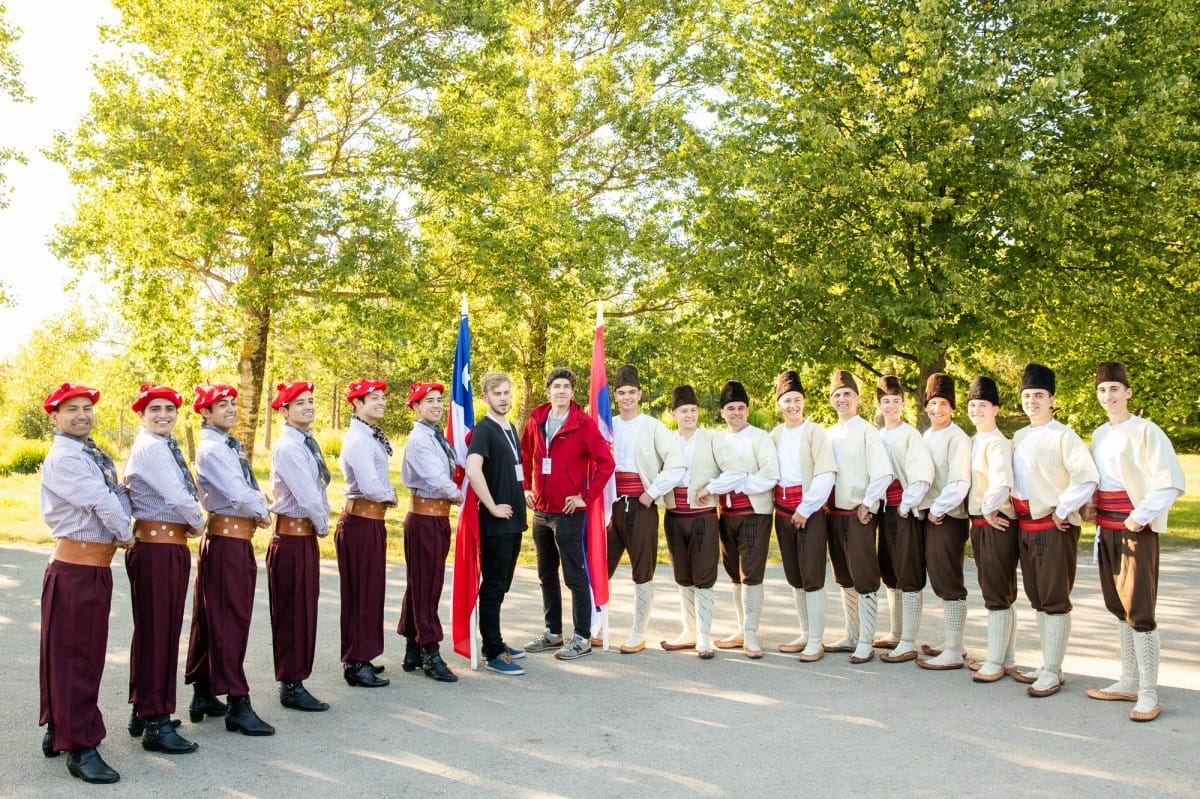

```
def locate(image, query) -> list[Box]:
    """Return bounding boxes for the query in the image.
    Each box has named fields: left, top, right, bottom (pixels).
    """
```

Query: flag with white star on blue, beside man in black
left=446, top=294, right=479, bottom=668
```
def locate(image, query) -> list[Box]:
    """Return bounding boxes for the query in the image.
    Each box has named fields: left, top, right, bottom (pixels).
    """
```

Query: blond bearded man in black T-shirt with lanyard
left=467, top=372, right=528, bottom=674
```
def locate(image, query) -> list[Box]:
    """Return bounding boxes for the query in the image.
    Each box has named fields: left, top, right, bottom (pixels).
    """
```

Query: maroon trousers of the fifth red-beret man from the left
left=334, top=512, right=388, bottom=663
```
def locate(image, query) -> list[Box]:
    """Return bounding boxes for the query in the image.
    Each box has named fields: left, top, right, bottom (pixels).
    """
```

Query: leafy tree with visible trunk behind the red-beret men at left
left=54, top=0, right=499, bottom=452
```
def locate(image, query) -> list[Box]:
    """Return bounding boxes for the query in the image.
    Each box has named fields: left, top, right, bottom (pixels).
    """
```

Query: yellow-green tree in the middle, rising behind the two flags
left=415, top=0, right=714, bottom=415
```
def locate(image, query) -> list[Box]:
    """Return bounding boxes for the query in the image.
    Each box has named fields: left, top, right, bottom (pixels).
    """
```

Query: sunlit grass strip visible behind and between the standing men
left=7, top=453, right=1200, bottom=566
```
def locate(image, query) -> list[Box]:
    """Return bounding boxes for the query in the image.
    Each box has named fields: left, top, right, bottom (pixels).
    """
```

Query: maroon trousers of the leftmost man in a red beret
left=37, top=560, right=113, bottom=752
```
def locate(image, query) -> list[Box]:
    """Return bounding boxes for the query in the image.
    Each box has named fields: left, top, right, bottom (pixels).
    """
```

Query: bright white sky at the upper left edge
left=0, top=0, right=115, bottom=359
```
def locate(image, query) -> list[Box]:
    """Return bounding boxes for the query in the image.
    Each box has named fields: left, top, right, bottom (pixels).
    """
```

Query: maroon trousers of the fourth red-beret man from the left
left=266, top=534, right=320, bottom=683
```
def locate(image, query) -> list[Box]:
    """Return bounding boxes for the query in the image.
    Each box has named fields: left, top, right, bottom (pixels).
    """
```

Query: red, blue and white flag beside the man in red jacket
left=583, top=305, right=617, bottom=649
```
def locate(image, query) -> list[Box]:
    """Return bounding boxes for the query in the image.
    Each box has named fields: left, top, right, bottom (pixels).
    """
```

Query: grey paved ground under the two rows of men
left=0, top=547, right=1200, bottom=799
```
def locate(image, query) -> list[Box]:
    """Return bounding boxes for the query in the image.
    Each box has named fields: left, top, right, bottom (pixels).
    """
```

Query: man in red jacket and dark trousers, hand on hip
left=521, top=368, right=616, bottom=660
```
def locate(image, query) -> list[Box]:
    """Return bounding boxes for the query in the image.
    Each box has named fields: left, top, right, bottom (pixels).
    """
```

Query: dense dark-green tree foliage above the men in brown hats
left=684, top=0, right=1200, bottom=422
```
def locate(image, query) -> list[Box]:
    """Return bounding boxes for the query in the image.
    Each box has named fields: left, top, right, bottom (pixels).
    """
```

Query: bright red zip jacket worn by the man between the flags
left=521, top=402, right=617, bottom=513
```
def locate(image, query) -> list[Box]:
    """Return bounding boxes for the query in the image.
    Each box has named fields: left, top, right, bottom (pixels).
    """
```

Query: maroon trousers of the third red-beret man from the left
left=184, top=534, right=258, bottom=697
